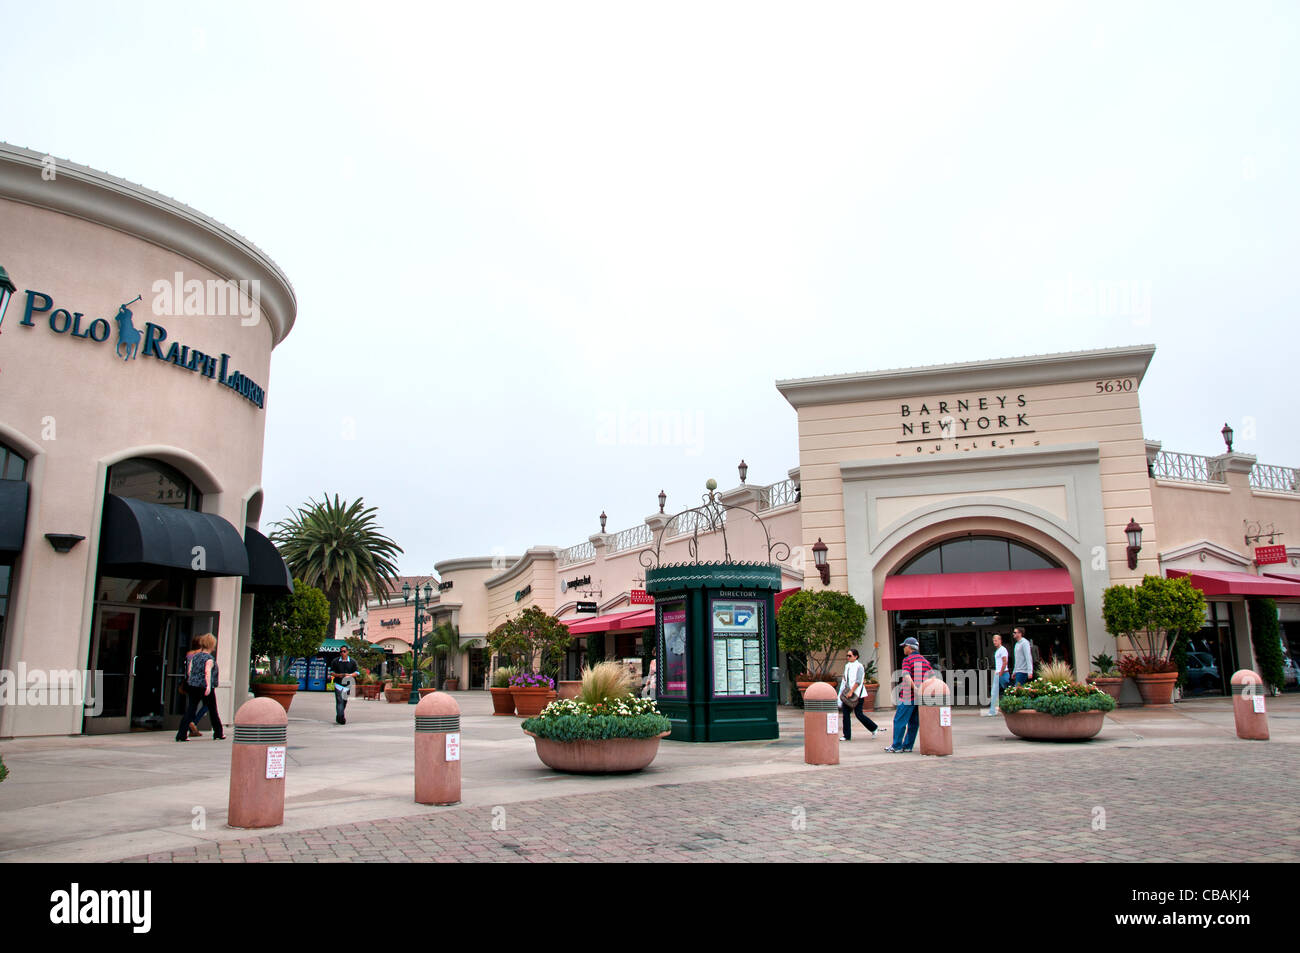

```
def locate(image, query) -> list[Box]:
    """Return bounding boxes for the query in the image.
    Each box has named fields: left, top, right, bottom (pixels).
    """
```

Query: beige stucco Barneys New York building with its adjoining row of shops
left=408, top=346, right=1300, bottom=699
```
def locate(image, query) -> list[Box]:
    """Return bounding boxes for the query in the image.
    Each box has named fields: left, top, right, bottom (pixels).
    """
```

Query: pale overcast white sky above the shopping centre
left=0, top=0, right=1300, bottom=575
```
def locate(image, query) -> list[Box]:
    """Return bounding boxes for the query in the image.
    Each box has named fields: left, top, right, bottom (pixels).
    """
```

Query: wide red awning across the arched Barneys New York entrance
left=883, top=569, right=1074, bottom=610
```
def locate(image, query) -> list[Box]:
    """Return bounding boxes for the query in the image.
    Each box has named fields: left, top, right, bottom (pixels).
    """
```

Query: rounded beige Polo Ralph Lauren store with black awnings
left=0, top=144, right=296, bottom=737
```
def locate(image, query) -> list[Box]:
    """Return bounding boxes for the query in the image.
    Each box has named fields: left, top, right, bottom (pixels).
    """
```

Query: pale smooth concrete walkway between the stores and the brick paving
left=0, top=692, right=1300, bottom=862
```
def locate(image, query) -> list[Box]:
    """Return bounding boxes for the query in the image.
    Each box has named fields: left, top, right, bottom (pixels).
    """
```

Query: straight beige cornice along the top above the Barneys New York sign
left=776, top=345, right=1156, bottom=410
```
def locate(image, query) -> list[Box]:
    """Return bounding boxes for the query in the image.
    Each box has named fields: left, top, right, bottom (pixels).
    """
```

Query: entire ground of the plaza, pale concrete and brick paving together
left=0, top=693, right=1300, bottom=862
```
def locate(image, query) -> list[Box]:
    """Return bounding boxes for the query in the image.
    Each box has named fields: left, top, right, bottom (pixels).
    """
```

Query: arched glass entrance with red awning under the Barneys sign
left=883, top=533, right=1074, bottom=705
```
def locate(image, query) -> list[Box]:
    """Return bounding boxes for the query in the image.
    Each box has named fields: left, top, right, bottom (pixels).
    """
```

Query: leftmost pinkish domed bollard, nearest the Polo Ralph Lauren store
left=226, top=698, right=289, bottom=828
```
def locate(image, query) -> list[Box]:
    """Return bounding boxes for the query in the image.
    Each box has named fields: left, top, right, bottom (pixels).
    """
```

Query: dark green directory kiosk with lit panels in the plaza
left=646, top=563, right=781, bottom=741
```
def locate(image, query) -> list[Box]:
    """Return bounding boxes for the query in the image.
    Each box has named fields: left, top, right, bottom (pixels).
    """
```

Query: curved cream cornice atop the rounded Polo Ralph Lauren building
left=0, top=142, right=298, bottom=346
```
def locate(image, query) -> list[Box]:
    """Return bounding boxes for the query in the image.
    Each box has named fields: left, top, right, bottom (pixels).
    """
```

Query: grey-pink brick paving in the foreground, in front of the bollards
left=124, top=745, right=1300, bottom=863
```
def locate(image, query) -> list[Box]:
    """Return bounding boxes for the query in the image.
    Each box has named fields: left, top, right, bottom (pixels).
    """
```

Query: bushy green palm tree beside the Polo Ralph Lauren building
left=270, top=494, right=402, bottom=638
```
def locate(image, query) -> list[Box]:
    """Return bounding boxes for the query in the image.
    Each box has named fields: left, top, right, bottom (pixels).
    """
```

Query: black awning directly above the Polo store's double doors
left=99, top=494, right=248, bottom=579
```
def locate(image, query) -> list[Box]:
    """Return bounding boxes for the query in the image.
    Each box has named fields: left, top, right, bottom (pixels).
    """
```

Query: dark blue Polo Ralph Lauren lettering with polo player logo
left=18, top=290, right=267, bottom=407
